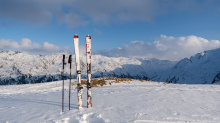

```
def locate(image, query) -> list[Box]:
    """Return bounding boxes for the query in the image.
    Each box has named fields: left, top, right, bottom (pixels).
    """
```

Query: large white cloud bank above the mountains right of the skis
left=96, top=35, right=220, bottom=61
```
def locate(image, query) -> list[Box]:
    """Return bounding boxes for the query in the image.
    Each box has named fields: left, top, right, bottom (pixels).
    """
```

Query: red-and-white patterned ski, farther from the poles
left=86, top=35, right=92, bottom=108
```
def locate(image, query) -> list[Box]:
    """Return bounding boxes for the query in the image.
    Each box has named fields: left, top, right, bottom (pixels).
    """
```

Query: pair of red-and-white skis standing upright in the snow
left=73, top=35, right=92, bottom=109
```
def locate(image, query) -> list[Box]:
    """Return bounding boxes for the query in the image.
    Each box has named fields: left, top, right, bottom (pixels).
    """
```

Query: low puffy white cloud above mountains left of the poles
left=0, top=38, right=59, bottom=52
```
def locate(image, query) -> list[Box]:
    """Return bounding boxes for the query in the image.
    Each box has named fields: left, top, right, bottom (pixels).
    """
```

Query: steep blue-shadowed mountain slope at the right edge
left=156, top=49, right=220, bottom=84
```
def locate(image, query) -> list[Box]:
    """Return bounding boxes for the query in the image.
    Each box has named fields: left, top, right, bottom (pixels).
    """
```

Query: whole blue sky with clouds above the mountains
left=0, top=0, right=220, bottom=61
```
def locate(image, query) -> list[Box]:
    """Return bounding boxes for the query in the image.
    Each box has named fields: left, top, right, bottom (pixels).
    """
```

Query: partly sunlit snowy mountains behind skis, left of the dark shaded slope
left=0, top=51, right=176, bottom=85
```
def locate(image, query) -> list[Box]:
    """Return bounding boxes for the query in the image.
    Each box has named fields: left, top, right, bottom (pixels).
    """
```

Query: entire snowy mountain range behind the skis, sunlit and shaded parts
left=0, top=49, right=220, bottom=85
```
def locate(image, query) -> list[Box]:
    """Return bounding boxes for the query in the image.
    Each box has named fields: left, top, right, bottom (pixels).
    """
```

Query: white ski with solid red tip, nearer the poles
left=73, top=35, right=83, bottom=109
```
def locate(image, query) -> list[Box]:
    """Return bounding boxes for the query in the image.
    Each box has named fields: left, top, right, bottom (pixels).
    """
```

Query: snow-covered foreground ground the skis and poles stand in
left=0, top=80, right=220, bottom=123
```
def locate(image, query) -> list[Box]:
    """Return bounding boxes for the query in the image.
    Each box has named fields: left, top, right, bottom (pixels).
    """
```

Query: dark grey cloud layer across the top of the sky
left=0, top=0, right=218, bottom=28
